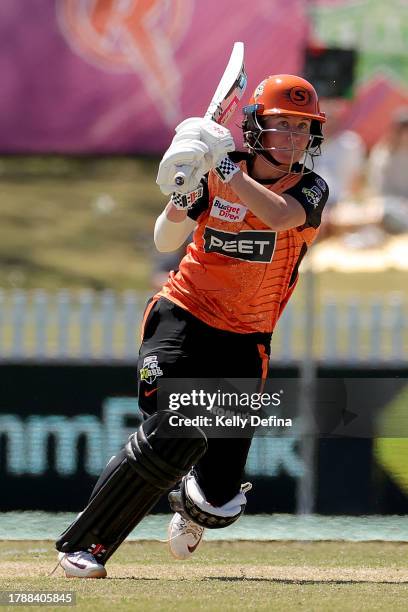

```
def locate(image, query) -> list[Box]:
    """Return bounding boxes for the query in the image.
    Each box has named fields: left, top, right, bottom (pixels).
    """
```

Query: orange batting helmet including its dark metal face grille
left=242, top=74, right=326, bottom=173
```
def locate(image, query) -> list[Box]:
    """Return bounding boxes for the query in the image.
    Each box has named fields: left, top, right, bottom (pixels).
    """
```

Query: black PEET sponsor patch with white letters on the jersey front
left=204, top=227, right=276, bottom=263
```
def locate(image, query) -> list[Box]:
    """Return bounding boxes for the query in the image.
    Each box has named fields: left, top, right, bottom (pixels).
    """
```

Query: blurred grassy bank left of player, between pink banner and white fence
left=0, top=157, right=161, bottom=290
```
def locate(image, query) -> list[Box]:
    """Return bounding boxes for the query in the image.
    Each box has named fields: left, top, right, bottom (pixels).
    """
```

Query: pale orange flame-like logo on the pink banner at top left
left=57, top=0, right=194, bottom=125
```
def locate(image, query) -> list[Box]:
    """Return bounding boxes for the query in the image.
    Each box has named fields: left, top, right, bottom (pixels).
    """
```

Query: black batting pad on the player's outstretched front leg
left=56, top=410, right=207, bottom=563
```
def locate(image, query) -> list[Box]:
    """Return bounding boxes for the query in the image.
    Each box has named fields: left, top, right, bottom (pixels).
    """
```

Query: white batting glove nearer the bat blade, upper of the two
left=173, top=117, right=235, bottom=167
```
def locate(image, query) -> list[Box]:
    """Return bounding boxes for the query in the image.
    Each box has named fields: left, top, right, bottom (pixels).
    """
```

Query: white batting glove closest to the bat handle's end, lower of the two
left=156, top=139, right=212, bottom=195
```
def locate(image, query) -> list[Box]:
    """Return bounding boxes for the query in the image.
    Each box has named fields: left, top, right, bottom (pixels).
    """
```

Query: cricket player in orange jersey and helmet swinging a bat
left=57, top=74, right=329, bottom=578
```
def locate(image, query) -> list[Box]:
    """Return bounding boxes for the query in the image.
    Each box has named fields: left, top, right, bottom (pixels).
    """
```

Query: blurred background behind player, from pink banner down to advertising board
left=0, top=0, right=408, bottom=532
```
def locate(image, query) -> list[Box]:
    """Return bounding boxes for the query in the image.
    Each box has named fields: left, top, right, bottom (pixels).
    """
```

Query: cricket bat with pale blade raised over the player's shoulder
left=174, top=42, right=248, bottom=185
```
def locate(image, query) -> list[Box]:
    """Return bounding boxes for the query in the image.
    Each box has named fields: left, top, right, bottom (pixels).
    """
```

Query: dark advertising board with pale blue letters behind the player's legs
left=0, top=364, right=408, bottom=514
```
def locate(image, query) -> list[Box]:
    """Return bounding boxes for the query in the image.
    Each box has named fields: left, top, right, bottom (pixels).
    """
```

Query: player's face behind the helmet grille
left=262, top=115, right=311, bottom=164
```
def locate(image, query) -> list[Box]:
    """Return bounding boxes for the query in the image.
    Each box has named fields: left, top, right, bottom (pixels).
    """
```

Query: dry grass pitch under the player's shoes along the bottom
left=0, top=541, right=408, bottom=612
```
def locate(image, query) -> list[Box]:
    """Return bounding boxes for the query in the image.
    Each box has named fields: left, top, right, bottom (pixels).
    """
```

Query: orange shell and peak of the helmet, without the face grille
left=249, top=74, right=326, bottom=123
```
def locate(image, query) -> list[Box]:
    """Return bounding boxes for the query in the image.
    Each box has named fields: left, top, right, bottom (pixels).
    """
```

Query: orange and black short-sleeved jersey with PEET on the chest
left=158, top=153, right=329, bottom=334
